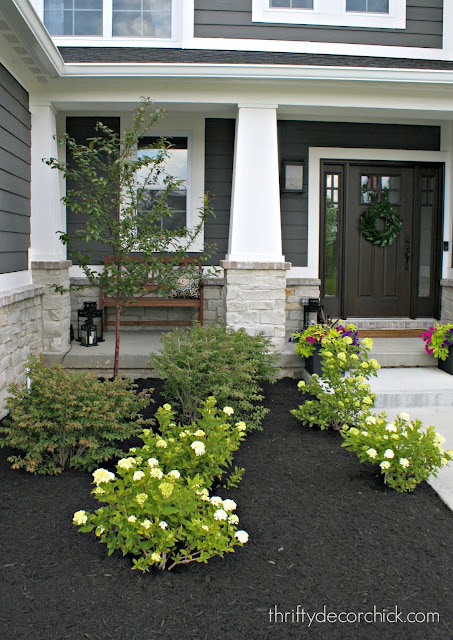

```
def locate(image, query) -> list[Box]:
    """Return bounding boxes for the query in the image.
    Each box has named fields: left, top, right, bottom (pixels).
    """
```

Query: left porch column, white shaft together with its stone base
left=29, top=104, right=71, bottom=354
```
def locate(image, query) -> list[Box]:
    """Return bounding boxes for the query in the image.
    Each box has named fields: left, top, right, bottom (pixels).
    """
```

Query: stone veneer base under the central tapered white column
left=220, top=260, right=291, bottom=353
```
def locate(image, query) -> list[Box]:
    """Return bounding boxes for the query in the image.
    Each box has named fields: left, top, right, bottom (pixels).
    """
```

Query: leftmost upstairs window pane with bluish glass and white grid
left=44, top=0, right=102, bottom=36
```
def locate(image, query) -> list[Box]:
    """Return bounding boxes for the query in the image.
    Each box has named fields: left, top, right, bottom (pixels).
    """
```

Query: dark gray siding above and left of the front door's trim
left=278, top=120, right=440, bottom=267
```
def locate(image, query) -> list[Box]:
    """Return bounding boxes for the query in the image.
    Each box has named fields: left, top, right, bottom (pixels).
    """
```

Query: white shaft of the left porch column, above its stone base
left=29, top=104, right=66, bottom=262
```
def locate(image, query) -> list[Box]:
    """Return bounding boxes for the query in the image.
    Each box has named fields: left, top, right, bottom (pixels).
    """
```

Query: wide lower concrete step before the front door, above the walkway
left=370, top=367, right=453, bottom=408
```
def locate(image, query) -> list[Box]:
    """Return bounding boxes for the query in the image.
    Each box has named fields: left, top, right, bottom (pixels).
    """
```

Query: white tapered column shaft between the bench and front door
left=227, top=105, right=284, bottom=262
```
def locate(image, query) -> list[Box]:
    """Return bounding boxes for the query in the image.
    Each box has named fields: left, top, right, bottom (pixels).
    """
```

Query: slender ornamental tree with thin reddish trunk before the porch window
left=43, top=98, right=212, bottom=377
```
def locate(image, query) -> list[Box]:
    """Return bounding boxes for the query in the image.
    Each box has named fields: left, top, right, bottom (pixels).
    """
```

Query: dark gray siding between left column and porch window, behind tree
left=66, top=116, right=120, bottom=264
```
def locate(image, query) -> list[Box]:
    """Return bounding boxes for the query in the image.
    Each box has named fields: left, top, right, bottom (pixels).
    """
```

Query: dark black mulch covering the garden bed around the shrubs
left=0, top=379, right=453, bottom=640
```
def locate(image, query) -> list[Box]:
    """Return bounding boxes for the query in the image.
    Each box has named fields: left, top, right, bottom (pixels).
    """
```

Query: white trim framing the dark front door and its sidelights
left=288, top=147, right=453, bottom=278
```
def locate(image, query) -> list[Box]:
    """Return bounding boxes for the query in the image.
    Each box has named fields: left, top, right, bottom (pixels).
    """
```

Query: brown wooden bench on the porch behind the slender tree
left=99, top=256, right=203, bottom=331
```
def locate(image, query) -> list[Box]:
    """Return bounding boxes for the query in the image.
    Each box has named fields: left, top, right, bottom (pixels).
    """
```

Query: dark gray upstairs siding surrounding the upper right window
left=195, top=0, right=443, bottom=49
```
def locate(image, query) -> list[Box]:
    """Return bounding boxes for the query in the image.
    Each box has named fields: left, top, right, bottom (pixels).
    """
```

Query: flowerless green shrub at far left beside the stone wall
left=0, top=357, right=150, bottom=474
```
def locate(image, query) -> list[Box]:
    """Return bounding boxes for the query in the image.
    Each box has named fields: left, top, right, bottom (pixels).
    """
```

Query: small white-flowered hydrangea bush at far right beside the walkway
left=341, top=412, right=453, bottom=491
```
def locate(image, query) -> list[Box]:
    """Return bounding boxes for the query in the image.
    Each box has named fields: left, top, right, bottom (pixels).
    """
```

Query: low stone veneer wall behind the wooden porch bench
left=70, top=277, right=225, bottom=333
